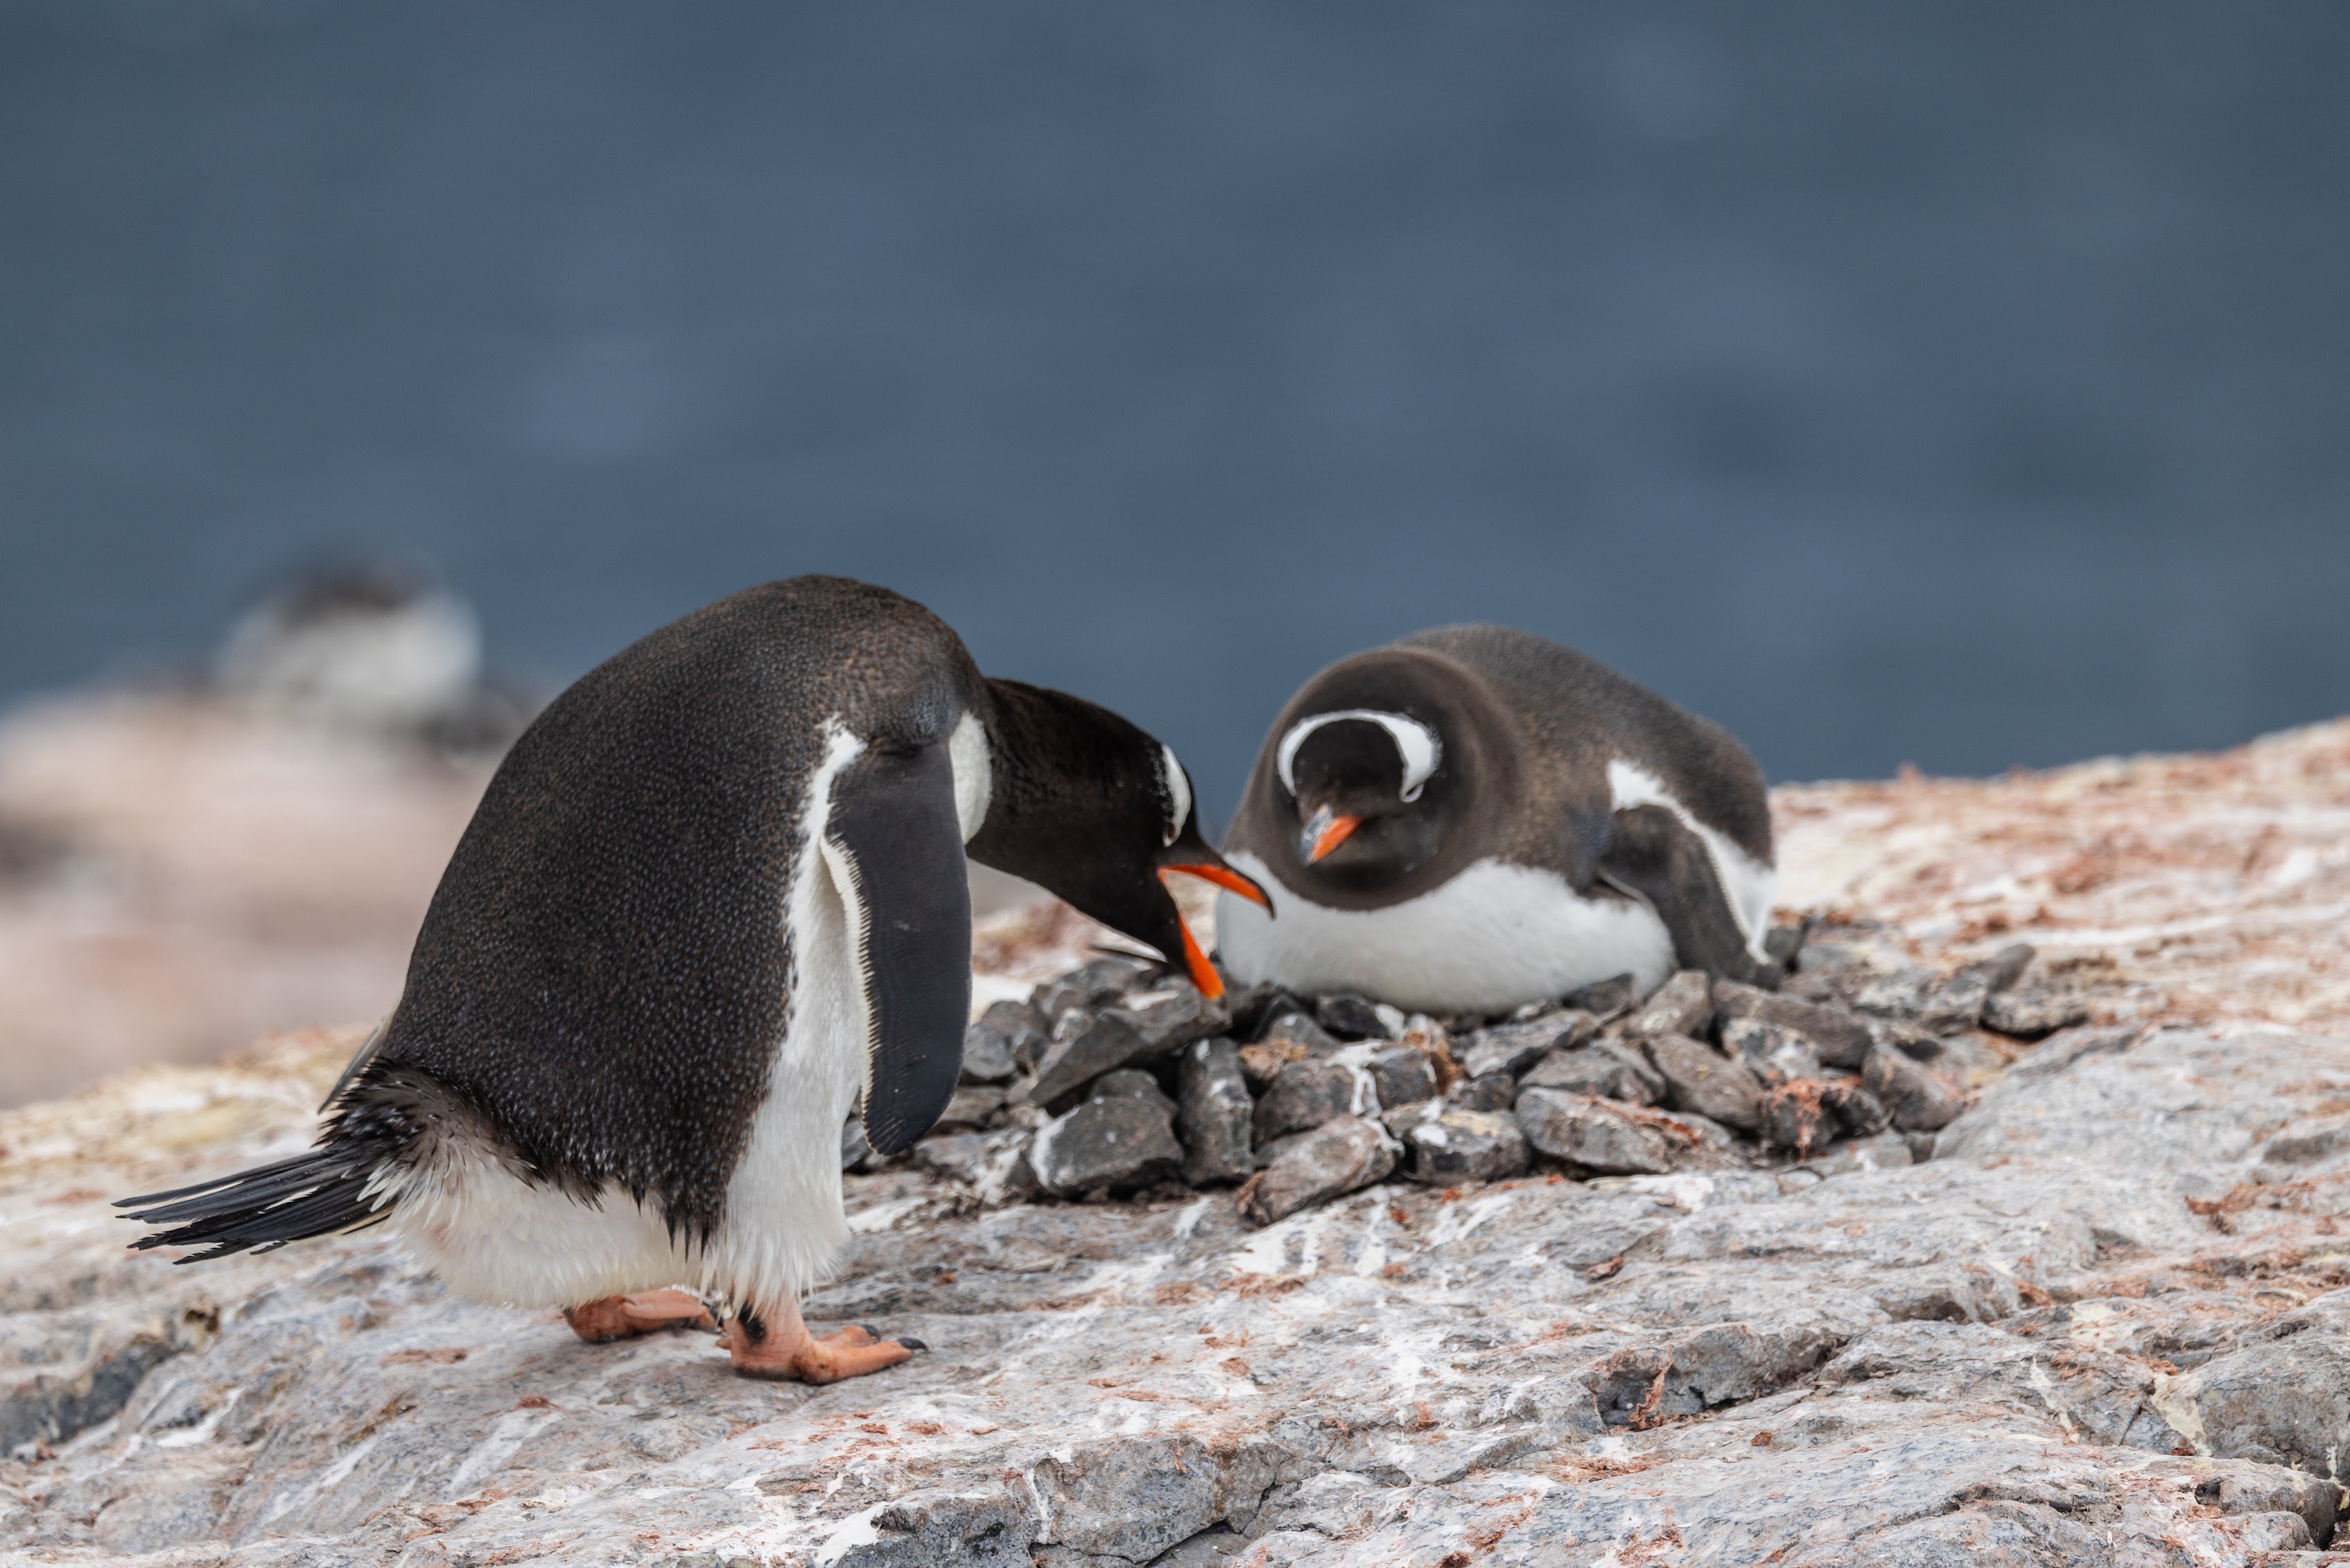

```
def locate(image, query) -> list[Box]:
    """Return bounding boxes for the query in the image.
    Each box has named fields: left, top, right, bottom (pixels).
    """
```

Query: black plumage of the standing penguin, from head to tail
left=125, top=576, right=1240, bottom=1255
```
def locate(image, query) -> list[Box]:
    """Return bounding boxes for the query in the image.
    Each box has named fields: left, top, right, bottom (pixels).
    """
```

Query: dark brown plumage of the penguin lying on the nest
left=1224, top=625, right=1774, bottom=983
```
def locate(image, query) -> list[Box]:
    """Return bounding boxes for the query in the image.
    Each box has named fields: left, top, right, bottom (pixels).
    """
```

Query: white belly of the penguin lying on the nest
left=1215, top=851, right=1673, bottom=1013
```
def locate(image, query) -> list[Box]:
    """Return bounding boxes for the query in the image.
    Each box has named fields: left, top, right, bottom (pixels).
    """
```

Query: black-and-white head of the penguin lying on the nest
left=1273, top=708, right=1454, bottom=891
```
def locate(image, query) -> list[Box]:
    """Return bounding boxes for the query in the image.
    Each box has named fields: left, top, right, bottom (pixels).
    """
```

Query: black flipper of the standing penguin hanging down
left=825, top=743, right=971, bottom=1154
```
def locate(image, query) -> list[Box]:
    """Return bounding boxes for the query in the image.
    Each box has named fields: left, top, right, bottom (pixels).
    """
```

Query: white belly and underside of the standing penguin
left=392, top=733, right=865, bottom=1312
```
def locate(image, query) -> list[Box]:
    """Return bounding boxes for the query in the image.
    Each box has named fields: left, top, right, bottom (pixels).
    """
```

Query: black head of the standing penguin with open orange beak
left=968, top=679, right=1273, bottom=997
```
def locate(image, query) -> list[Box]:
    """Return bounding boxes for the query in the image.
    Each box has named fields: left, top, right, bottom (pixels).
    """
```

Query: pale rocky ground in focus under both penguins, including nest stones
left=0, top=724, right=2350, bottom=1568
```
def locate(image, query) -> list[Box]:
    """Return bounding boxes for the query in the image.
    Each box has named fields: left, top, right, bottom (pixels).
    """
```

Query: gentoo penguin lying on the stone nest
left=1217, top=625, right=1772, bottom=1013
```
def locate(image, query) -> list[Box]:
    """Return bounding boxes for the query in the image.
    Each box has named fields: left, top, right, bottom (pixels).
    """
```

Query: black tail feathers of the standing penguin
left=115, top=1138, right=392, bottom=1262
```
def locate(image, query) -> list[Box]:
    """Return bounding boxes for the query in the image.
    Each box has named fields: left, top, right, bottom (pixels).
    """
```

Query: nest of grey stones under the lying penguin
left=902, top=921, right=2127, bottom=1225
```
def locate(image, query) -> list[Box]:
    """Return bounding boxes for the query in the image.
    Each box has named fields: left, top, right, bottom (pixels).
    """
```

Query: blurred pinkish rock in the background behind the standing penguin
left=0, top=696, right=489, bottom=1105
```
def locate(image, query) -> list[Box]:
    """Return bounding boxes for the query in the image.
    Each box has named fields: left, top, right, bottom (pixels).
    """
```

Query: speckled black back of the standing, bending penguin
left=362, top=576, right=987, bottom=1237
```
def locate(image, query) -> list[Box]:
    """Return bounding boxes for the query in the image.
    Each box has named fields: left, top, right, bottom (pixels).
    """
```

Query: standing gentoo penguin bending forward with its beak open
left=122, top=576, right=1264, bottom=1382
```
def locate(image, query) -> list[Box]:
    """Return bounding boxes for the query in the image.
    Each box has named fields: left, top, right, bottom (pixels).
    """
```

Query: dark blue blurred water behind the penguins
left=0, top=0, right=2350, bottom=811
